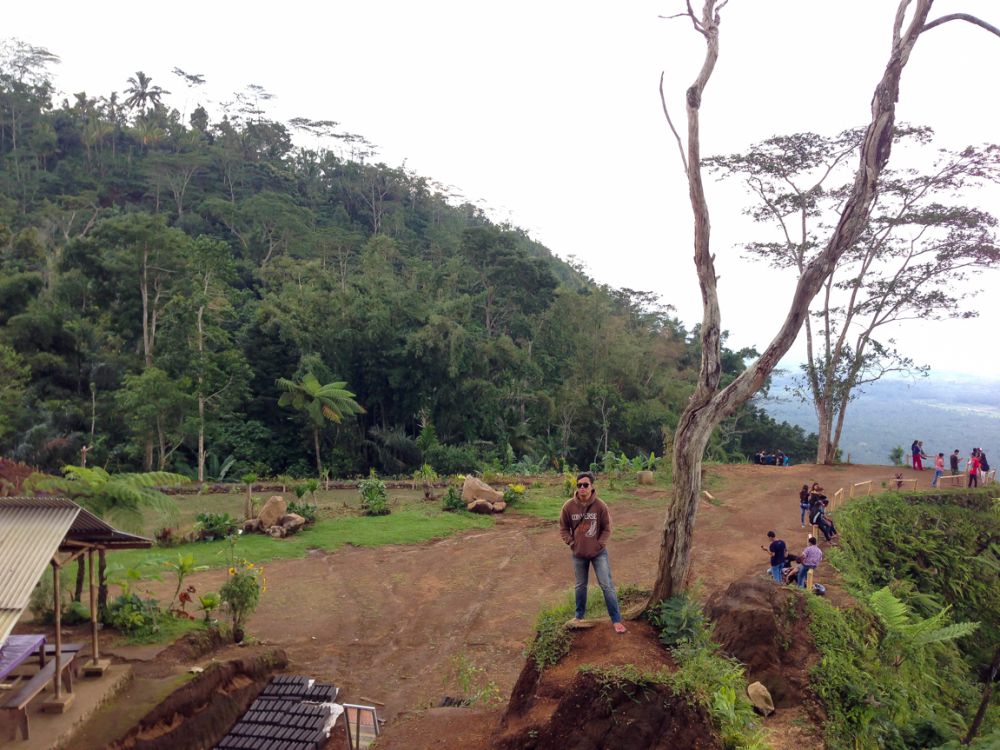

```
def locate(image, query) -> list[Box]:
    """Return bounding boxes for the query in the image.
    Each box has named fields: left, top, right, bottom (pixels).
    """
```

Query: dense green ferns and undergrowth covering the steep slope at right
left=809, top=490, right=1000, bottom=749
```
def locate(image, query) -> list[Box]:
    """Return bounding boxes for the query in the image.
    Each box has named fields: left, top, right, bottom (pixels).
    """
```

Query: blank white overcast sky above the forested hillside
left=0, top=0, right=1000, bottom=382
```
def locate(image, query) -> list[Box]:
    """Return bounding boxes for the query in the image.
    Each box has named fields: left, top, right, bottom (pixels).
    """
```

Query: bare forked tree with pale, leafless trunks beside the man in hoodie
left=651, top=0, right=1000, bottom=601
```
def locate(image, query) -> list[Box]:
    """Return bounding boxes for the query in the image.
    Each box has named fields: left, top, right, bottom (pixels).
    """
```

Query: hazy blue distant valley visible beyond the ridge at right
left=758, top=373, right=1000, bottom=464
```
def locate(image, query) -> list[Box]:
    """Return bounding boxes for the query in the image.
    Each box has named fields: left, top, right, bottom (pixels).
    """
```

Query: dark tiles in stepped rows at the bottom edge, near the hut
left=216, top=675, right=337, bottom=750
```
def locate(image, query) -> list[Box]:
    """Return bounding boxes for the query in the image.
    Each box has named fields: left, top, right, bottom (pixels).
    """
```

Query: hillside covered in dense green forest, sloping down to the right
left=0, top=43, right=815, bottom=479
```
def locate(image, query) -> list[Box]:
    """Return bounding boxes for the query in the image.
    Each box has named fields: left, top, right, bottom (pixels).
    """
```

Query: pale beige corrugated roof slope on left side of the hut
left=0, top=498, right=81, bottom=643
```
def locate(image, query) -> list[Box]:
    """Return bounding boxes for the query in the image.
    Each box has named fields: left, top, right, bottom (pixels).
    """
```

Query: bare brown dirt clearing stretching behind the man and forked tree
left=84, top=465, right=916, bottom=748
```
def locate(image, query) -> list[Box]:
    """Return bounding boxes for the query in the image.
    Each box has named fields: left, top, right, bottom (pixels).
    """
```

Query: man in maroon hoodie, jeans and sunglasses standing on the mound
left=559, top=471, right=626, bottom=633
